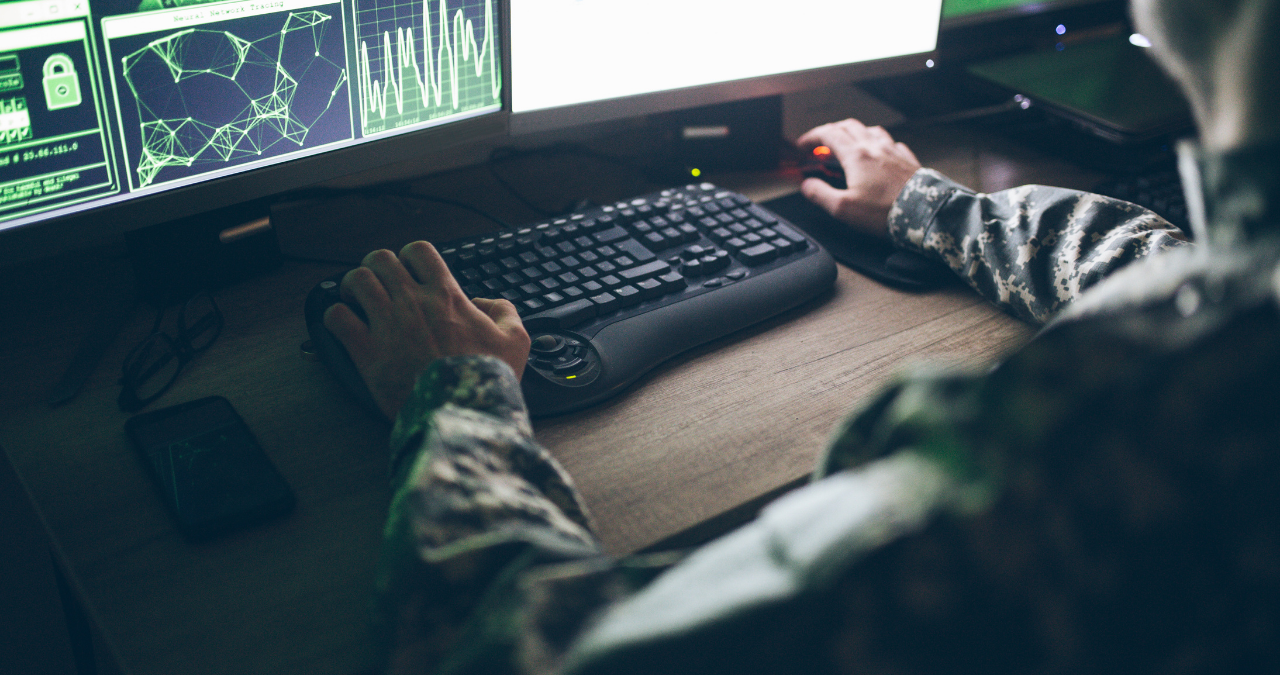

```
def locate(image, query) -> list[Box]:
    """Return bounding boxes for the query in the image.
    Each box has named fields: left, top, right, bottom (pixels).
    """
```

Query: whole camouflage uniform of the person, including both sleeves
left=379, top=147, right=1280, bottom=674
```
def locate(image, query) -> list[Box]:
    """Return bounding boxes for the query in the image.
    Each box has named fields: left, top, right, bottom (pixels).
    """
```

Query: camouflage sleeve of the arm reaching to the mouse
left=888, top=169, right=1188, bottom=324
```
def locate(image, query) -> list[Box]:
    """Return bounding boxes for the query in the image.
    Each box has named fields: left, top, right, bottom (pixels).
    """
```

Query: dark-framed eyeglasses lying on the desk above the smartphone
left=118, top=292, right=223, bottom=412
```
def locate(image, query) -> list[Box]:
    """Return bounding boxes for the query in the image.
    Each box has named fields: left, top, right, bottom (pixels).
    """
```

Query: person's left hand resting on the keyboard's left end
left=324, top=241, right=529, bottom=419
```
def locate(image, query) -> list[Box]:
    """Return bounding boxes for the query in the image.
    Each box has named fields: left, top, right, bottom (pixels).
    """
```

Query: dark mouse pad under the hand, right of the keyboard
left=760, top=192, right=960, bottom=292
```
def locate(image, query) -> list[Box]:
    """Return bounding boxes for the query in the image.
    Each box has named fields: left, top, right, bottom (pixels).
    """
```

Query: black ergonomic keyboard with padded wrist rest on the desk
left=306, top=183, right=836, bottom=416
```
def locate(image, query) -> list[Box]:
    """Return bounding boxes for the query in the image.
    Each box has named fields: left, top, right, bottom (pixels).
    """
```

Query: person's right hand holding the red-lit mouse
left=796, top=119, right=920, bottom=238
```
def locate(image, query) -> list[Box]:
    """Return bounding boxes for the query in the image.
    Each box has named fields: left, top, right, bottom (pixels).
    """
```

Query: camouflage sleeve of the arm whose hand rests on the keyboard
left=376, top=356, right=599, bottom=672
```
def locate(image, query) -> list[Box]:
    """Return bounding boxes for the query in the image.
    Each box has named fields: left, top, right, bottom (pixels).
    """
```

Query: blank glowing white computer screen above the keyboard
left=511, top=0, right=942, bottom=133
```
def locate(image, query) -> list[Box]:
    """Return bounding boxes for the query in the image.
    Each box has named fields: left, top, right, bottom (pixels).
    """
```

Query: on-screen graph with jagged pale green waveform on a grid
left=352, top=0, right=502, bottom=136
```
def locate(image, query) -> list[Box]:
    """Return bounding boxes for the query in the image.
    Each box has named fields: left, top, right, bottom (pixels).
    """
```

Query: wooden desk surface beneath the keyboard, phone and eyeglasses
left=0, top=122, right=1096, bottom=675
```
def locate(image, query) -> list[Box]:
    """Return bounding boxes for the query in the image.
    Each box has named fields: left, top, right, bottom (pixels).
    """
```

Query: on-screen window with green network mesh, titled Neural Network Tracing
left=102, top=0, right=355, bottom=190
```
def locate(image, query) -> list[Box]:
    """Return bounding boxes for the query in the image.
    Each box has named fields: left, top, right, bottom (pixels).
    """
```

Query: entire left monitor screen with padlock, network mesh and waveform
left=0, top=0, right=502, bottom=229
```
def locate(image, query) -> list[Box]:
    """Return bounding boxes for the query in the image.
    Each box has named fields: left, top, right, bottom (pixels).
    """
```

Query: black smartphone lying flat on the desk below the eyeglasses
left=124, top=396, right=294, bottom=541
